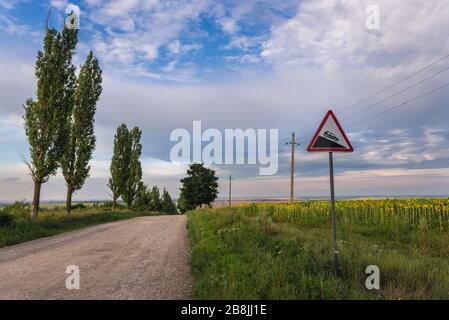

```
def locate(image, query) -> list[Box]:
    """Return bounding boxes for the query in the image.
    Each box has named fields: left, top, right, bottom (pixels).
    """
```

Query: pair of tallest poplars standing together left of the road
left=23, top=26, right=102, bottom=217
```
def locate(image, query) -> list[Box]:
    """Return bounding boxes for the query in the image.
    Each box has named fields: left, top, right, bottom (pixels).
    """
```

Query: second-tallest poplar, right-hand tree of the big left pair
left=61, top=52, right=102, bottom=214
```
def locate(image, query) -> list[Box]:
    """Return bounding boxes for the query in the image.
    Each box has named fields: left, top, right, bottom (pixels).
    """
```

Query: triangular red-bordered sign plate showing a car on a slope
left=307, top=111, right=354, bottom=152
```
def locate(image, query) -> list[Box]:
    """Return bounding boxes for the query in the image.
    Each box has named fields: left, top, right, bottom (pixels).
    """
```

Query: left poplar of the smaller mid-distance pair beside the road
left=108, top=124, right=132, bottom=210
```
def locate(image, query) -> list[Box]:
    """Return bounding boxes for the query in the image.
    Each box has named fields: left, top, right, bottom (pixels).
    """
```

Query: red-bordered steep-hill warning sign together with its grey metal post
left=307, top=111, right=354, bottom=274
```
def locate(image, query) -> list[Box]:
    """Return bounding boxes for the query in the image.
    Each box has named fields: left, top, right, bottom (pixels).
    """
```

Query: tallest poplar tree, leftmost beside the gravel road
left=23, top=28, right=78, bottom=217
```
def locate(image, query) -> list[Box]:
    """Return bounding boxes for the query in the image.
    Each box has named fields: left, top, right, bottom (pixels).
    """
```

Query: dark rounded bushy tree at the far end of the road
left=181, top=163, right=218, bottom=211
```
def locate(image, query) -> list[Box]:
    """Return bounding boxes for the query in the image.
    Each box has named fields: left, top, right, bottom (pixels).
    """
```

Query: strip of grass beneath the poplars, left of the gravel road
left=0, top=204, right=156, bottom=248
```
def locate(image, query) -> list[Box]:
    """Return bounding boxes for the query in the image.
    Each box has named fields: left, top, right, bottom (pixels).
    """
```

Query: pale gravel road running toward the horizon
left=0, top=215, right=191, bottom=299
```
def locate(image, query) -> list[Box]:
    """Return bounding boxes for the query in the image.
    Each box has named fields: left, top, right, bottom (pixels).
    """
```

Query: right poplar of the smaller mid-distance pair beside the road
left=121, top=127, right=142, bottom=207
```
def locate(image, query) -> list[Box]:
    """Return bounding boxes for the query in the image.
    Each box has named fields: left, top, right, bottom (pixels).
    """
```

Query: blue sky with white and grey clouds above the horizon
left=0, top=0, right=449, bottom=201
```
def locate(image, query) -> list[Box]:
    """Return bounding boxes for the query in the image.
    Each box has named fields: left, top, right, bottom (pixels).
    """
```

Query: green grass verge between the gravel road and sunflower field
left=188, top=207, right=449, bottom=299
